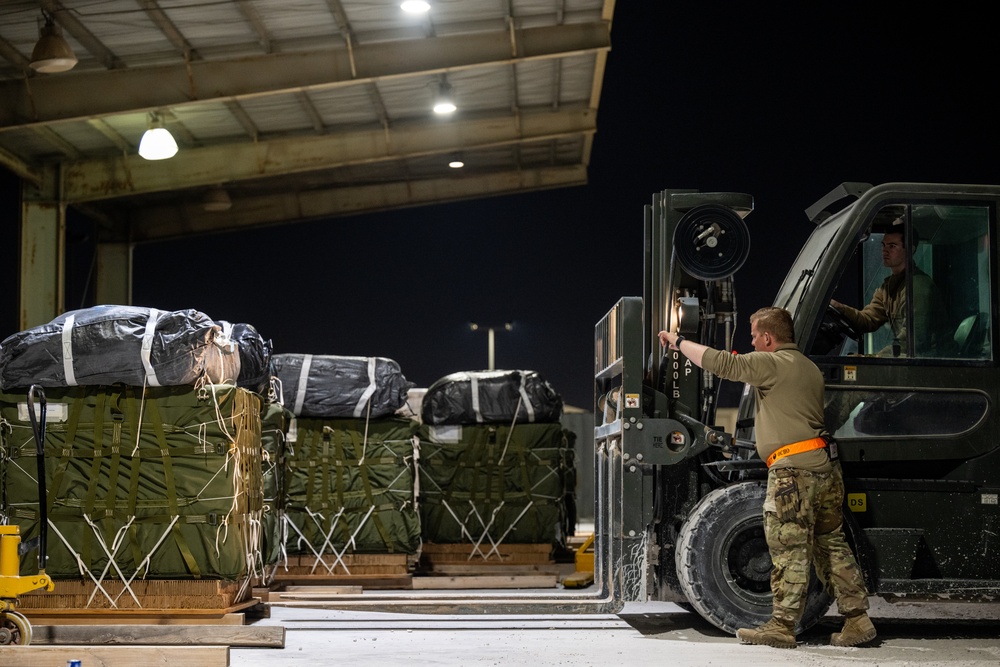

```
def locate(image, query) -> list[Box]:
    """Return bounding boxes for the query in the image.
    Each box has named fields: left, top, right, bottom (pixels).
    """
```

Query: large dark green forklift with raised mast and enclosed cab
left=595, top=183, right=1000, bottom=632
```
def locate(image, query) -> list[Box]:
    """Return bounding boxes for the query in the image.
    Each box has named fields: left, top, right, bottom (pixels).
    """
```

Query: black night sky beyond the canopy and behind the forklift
left=0, top=5, right=998, bottom=409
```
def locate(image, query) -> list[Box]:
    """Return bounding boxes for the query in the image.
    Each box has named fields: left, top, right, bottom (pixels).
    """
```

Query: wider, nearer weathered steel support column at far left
left=18, top=167, right=66, bottom=330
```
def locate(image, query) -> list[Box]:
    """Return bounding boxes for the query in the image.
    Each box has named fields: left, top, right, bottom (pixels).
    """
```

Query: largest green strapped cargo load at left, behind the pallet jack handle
left=0, top=385, right=263, bottom=582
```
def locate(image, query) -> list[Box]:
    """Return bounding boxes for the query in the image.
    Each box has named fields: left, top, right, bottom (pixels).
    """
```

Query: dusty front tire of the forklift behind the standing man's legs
left=676, top=481, right=832, bottom=633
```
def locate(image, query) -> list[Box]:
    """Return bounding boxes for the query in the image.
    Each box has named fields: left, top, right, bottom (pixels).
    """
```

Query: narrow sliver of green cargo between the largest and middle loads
left=260, top=403, right=295, bottom=565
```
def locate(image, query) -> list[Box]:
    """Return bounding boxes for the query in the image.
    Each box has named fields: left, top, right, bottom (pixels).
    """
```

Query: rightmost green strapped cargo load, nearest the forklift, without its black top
left=420, top=424, right=576, bottom=552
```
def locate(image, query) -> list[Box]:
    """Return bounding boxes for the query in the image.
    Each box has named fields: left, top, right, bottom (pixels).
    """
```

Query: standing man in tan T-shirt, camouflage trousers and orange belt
left=660, top=308, right=875, bottom=648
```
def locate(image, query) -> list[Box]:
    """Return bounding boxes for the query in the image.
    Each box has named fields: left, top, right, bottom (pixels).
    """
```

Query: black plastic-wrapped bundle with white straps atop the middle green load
left=272, top=354, right=414, bottom=419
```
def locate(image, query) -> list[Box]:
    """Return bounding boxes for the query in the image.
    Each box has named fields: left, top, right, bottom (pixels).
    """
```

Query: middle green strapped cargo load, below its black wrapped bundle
left=285, top=417, right=420, bottom=556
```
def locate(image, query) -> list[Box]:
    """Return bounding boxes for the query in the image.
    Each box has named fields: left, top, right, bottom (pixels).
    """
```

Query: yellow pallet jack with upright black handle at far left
left=0, top=384, right=55, bottom=646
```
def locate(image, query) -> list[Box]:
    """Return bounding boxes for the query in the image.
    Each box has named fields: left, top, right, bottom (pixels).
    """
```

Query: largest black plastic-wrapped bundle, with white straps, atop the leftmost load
left=0, top=305, right=240, bottom=390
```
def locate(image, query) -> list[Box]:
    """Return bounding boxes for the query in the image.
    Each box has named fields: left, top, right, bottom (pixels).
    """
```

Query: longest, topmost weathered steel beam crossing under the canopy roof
left=0, top=22, right=611, bottom=132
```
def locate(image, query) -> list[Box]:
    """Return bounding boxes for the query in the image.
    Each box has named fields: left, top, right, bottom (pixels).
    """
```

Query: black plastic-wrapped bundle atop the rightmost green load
left=421, top=370, right=563, bottom=424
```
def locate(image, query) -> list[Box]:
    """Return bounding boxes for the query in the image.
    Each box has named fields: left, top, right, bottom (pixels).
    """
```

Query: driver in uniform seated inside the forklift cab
left=830, top=227, right=947, bottom=357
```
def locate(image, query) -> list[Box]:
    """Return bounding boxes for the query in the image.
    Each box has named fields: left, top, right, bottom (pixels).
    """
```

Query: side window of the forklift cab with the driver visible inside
left=814, top=204, right=993, bottom=360
